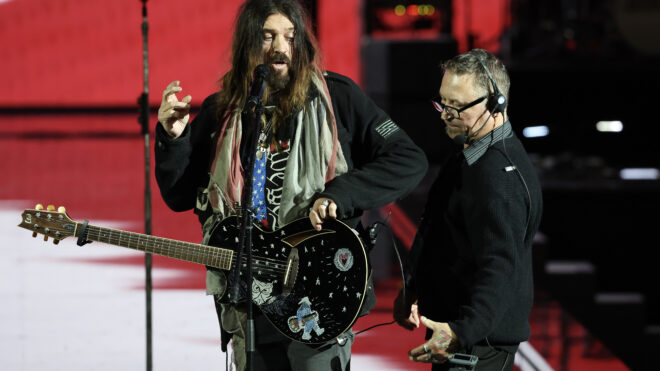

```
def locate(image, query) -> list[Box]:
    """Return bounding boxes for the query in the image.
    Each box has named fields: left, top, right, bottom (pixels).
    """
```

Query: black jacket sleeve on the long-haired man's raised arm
left=154, top=95, right=217, bottom=211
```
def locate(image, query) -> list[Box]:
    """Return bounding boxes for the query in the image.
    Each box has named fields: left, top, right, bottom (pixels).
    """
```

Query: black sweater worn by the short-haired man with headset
left=410, top=135, right=542, bottom=347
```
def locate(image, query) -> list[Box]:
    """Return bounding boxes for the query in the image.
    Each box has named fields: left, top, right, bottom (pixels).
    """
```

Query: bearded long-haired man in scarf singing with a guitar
left=156, top=0, right=427, bottom=370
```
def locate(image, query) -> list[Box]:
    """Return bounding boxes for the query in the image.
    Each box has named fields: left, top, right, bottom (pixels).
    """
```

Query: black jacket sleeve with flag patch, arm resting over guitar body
left=320, top=73, right=428, bottom=219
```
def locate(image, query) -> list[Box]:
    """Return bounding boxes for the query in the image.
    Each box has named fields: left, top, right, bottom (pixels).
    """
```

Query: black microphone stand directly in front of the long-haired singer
left=230, top=99, right=264, bottom=370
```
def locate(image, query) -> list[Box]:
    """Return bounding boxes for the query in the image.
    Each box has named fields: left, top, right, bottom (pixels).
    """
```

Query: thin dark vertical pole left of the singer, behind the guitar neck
left=138, top=0, right=153, bottom=371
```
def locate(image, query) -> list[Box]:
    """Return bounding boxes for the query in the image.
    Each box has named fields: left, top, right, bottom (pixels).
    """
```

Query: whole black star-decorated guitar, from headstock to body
left=18, top=205, right=368, bottom=344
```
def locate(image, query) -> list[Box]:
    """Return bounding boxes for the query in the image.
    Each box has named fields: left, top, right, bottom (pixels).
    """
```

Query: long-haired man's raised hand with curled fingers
left=158, top=81, right=192, bottom=138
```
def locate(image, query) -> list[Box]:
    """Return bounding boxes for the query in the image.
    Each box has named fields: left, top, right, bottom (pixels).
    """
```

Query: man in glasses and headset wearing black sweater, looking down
left=394, top=49, right=542, bottom=371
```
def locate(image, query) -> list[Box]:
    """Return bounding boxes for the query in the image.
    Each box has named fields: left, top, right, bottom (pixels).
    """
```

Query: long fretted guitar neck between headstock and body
left=80, top=223, right=234, bottom=270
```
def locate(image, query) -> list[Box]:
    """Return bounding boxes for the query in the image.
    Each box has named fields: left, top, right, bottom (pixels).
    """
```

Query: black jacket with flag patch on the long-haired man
left=155, top=72, right=428, bottom=227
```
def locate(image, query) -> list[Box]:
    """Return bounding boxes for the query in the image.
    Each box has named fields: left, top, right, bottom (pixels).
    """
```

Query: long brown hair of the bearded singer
left=217, top=0, right=321, bottom=124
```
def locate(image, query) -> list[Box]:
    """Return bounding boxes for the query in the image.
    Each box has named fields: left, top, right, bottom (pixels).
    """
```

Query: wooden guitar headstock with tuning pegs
left=18, top=204, right=76, bottom=245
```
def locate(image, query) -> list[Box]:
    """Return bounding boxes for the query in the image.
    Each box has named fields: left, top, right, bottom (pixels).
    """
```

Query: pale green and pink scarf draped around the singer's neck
left=205, top=73, right=348, bottom=230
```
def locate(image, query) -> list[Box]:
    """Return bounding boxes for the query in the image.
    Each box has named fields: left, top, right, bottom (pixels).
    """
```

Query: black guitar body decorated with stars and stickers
left=209, top=217, right=369, bottom=344
